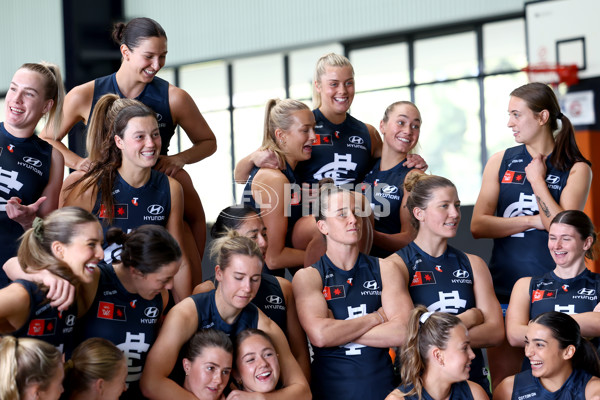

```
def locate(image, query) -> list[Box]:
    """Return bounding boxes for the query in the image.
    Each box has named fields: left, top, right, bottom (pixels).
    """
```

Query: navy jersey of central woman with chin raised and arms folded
left=311, top=254, right=394, bottom=400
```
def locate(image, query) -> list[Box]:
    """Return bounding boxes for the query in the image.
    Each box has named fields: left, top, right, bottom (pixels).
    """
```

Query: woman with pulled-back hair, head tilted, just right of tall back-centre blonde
left=361, top=101, right=422, bottom=257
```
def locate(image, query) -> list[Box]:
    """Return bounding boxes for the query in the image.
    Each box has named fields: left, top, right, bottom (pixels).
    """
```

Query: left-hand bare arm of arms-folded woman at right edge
left=506, top=277, right=531, bottom=347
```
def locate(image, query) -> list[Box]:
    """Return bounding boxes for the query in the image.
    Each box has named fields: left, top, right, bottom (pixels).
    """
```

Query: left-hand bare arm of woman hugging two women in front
left=140, top=298, right=198, bottom=400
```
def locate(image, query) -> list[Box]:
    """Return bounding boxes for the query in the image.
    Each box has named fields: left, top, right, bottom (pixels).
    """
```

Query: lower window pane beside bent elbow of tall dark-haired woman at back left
left=181, top=111, right=234, bottom=223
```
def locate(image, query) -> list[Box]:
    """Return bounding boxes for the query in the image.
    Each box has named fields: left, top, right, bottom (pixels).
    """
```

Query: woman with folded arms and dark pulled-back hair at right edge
left=506, top=210, right=600, bottom=354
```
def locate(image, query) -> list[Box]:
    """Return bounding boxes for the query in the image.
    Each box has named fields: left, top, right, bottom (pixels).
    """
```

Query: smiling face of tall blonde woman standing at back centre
left=315, top=66, right=355, bottom=115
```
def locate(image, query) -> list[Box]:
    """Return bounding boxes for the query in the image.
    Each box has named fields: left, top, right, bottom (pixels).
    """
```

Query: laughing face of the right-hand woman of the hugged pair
left=235, top=335, right=280, bottom=393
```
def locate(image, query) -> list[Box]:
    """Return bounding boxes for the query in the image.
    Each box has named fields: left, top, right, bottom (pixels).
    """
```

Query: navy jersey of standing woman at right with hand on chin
left=490, top=145, right=569, bottom=303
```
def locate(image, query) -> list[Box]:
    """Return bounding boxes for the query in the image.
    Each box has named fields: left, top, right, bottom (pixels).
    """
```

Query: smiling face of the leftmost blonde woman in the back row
left=4, top=68, right=53, bottom=133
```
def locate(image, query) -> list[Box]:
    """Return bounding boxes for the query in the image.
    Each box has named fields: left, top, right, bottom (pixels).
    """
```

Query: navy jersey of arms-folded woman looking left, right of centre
left=396, top=242, right=490, bottom=394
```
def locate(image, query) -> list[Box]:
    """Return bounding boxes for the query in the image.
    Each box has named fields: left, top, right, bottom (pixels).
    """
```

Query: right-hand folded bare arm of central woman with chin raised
left=354, top=259, right=413, bottom=348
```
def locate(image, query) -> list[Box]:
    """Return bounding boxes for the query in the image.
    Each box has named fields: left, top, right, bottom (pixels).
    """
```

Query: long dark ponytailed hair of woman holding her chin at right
left=510, top=82, right=592, bottom=171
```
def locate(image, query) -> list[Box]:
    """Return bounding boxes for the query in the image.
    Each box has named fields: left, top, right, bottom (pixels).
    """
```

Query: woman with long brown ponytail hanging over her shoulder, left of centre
left=64, top=94, right=192, bottom=301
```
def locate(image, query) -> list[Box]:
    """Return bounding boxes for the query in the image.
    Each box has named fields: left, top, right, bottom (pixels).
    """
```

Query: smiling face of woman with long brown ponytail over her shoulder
left=115, top=116, right=161, bottom=168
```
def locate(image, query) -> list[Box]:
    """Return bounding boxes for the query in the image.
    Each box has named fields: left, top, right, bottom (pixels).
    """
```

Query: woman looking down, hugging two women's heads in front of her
left=141, top=232, right=310, bottom=399
